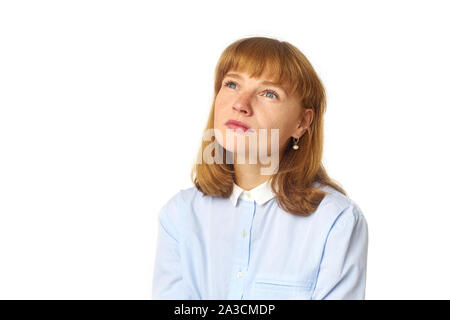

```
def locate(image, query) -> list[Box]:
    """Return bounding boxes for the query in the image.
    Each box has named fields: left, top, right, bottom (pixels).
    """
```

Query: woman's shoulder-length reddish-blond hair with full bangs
left=191, top=37, right=346, bottom=216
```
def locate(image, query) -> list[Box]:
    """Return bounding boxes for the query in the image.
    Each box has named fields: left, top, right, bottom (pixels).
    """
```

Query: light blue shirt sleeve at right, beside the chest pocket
left=311, top=204, right=368, bottom=300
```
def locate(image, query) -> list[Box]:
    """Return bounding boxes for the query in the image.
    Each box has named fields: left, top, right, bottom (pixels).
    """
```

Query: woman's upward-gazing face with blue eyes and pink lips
left=214, top=71, right=312, bottom=160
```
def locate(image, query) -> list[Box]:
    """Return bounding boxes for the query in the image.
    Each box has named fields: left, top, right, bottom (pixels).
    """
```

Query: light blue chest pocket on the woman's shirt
left=247, top=277, right=313, bottom=300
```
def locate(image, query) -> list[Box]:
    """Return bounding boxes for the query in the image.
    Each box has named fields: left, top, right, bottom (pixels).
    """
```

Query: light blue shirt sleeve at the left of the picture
left=152, top=195, right=191, bottom=300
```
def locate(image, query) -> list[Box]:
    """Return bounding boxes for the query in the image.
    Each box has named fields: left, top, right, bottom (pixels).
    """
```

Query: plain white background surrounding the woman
left=0, top=0, right=450, bottom=299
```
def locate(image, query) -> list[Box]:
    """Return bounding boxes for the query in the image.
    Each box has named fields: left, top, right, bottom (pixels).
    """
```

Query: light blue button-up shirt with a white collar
left=152, top=180, right=368, bottom=300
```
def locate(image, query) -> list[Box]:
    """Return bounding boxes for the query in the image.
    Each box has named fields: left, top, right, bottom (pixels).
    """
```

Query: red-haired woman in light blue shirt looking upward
left=152, top=37, right=368, bottom=299
